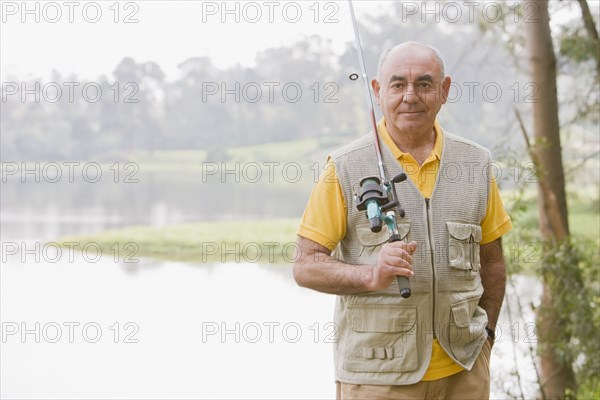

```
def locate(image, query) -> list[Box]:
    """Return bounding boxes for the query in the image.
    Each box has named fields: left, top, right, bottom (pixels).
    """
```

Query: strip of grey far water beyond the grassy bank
left=0, top=169, right=310, bottom=240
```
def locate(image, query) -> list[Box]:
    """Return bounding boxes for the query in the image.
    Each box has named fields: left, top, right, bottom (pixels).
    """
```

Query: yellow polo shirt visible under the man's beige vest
left=297, top=118, right=512, bottom=381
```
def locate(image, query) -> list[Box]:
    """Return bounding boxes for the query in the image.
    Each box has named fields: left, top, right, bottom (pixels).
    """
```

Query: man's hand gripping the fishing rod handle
left=368, top=242, right=417, bottom=291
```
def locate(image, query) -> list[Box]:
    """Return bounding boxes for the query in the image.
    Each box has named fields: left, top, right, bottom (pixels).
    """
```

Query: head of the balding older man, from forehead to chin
left=372, top=45, right=450, bottom=136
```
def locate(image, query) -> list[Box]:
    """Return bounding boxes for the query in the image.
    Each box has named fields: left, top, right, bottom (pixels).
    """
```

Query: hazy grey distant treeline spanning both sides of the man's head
left=0, top=4, right=592, bottom=161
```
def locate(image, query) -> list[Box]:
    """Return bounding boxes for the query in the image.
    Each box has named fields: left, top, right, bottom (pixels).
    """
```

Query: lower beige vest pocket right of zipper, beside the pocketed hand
left=448, top=297, right=487, bottom=362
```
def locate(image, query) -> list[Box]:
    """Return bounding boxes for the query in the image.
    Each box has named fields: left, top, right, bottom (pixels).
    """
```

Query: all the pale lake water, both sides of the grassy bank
left=0, top=173, right=540, bottom=399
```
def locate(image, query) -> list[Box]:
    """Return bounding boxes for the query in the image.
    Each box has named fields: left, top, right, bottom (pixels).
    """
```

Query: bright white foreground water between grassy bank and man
left=0, top=255, right=333, bottom=398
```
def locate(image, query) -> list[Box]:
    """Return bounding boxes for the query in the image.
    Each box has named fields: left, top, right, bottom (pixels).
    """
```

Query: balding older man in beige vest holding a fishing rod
left=294, top=42, right=512, bottom=399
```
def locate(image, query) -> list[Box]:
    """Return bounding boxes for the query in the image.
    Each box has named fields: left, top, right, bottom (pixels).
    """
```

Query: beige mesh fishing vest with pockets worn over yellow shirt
left=332, top=128, right=490, bottom=385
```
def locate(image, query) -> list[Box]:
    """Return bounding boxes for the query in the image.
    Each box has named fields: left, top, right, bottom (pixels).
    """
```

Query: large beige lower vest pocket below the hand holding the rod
left=344, top=305, right=419, bottom=372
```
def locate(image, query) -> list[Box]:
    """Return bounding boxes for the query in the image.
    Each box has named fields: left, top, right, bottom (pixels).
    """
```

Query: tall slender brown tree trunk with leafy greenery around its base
left=523, top=0, right=591, bottom=399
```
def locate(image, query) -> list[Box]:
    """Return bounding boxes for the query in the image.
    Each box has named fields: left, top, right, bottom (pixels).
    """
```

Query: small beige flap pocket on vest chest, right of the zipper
left=446, top=221, right=482, bottom=276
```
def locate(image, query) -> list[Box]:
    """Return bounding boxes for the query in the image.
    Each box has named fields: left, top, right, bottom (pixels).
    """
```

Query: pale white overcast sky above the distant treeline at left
left=0, top=1, right=389, bottom=79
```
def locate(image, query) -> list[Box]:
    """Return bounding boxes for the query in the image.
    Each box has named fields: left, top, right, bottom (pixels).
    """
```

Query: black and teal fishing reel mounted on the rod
left=356, top=172, right=406, bottom=233
